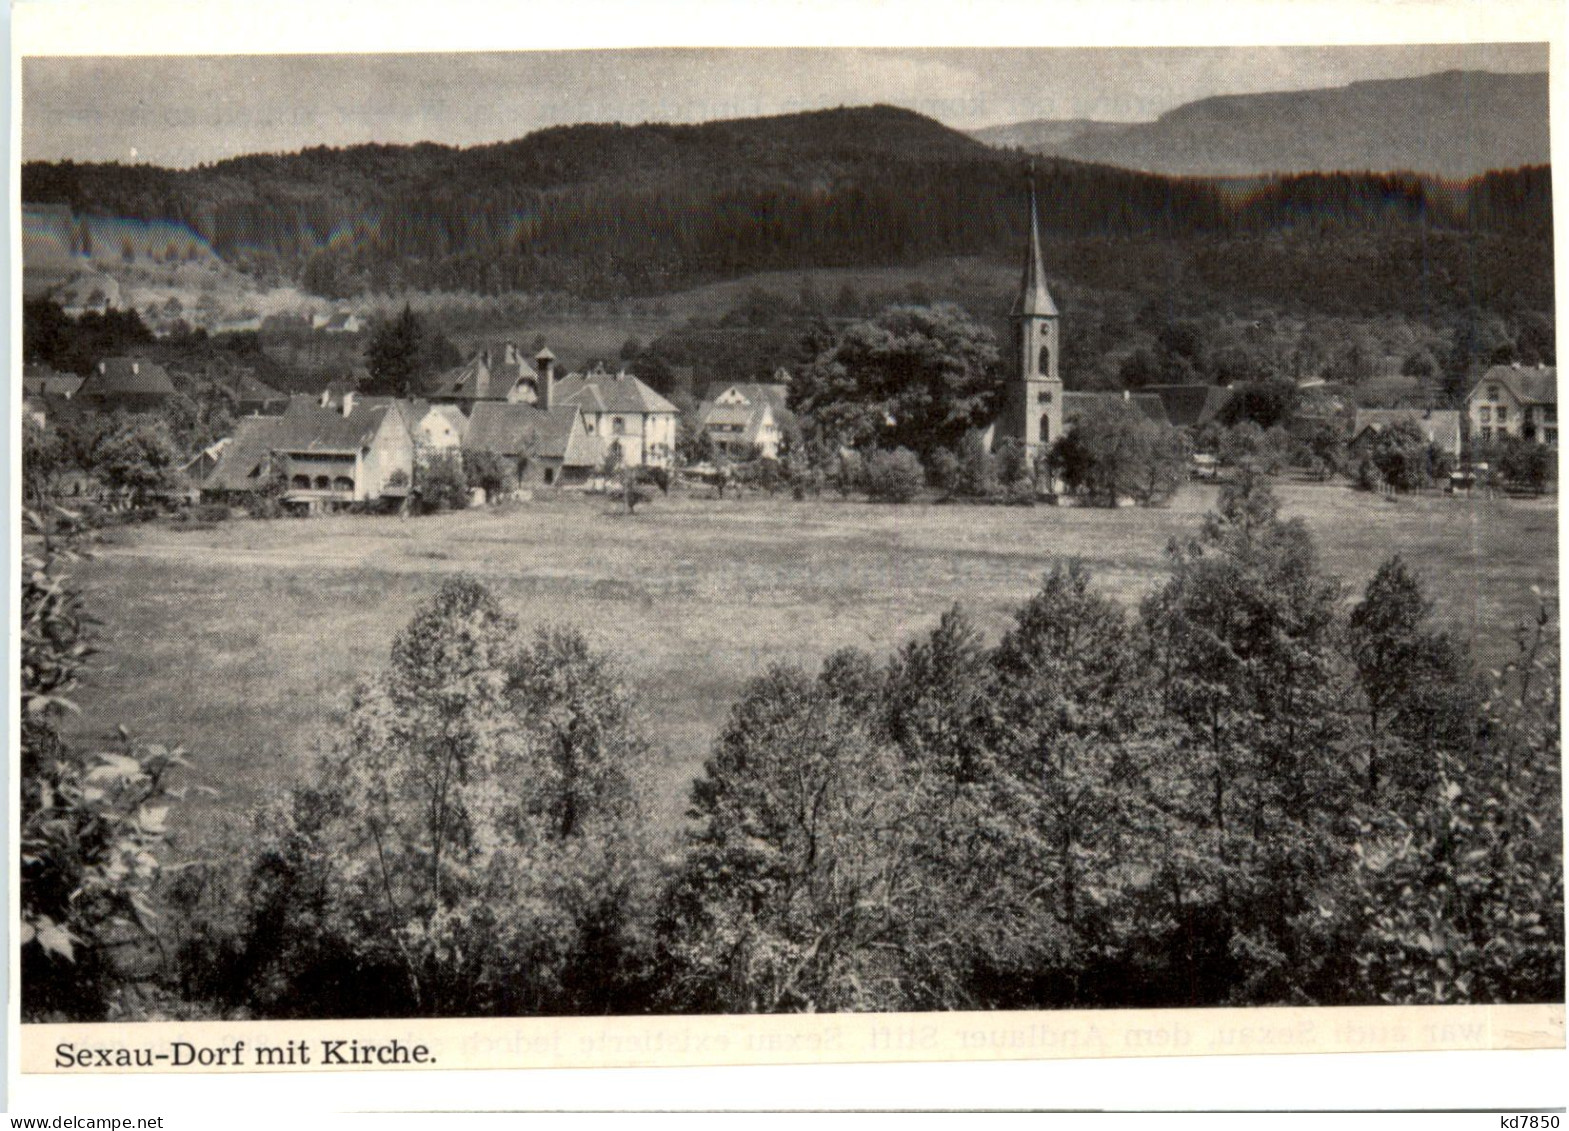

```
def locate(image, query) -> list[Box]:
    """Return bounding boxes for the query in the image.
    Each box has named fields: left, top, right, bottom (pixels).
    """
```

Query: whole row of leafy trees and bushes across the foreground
left=22, top=477, right=1563, bottom=1020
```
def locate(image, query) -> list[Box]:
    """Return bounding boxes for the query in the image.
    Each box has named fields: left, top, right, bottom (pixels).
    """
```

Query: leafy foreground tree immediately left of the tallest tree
left=992, top=565, right=1170, bottom=1006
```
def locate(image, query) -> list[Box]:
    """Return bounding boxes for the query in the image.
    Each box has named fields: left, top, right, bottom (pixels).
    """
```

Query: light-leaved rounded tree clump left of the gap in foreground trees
left=185, top=579, right=645, bottom=1016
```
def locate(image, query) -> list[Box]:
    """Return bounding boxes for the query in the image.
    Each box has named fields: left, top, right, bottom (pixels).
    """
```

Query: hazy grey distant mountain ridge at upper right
left=971, top=71, right=1550, bottom=179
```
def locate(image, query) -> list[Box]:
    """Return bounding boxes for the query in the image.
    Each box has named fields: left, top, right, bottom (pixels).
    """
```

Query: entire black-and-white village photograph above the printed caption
left=13, top=44, right=1564, bottom=1023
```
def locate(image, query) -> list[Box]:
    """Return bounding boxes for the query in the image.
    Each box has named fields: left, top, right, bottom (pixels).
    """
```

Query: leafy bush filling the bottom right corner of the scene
left=1346, top=602, right=1564, bottom=1004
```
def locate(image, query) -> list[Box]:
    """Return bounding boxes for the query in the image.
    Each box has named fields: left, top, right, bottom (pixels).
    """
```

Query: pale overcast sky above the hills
left=22, top=44, right=1547, bottom=166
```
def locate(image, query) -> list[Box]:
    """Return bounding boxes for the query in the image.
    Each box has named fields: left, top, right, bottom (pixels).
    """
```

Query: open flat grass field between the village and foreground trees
left=64, top=485, right=1558, bottom=850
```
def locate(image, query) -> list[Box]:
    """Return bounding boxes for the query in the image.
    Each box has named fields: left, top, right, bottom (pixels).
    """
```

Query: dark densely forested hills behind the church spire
left=22, top=107, right=1552, bottom=312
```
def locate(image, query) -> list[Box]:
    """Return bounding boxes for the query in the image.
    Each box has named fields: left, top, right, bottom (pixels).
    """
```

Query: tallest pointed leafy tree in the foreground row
left=1144, top=475, right=1351, bottom=1001
